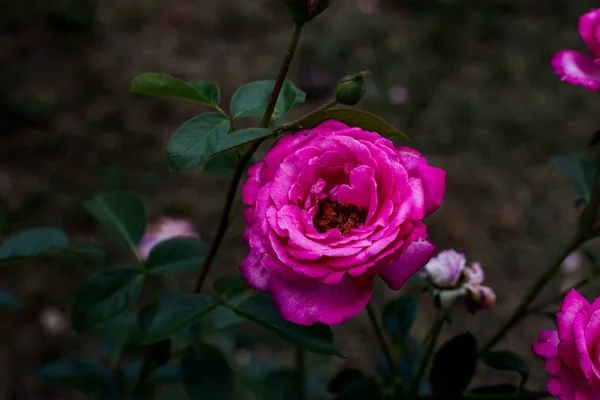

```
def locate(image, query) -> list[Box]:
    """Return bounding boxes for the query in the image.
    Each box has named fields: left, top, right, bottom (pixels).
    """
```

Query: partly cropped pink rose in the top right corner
left=550, top=9, right=600, bottom=90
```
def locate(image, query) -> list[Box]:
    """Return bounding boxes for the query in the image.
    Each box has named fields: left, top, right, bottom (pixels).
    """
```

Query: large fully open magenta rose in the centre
left=240, top=120, right=446, bottom=325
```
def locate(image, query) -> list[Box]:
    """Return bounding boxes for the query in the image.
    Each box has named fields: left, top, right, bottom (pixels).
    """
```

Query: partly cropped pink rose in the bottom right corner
left=533, top=290, right=600, bottom=400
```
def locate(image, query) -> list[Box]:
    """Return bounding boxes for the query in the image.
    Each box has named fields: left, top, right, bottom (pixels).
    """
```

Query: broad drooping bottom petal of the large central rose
left=269, top=273, right=373, bottom=326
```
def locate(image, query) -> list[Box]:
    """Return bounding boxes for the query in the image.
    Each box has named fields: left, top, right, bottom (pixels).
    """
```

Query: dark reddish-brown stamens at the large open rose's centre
left=313, top=199, right=366, bottom=235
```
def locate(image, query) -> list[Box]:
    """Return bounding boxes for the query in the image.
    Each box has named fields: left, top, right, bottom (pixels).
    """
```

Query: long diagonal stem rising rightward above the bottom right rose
left=480, top=234, right=586, bottom=353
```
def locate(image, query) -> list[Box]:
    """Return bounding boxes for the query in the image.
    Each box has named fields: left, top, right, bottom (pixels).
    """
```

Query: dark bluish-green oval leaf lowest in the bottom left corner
left=38, top=357, right=110, bottom=394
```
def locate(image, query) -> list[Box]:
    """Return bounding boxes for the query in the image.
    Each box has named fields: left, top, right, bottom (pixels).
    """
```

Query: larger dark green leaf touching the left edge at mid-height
left=0, top=228, right=69, bottom=261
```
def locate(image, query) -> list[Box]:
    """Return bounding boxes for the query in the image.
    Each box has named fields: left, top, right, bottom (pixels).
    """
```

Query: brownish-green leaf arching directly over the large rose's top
left=302, top=108, right=408, bottom=139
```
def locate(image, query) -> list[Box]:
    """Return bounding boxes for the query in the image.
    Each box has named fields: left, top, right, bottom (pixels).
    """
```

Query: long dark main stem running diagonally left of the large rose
left=194, top=24, right=302, bottom=293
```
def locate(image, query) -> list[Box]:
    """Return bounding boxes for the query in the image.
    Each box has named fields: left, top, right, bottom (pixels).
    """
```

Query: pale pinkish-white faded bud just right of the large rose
left=419, top=250, right=467, bottom=289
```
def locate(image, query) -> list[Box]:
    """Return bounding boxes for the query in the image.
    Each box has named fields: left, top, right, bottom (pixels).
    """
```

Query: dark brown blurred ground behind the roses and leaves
left=0, top=0, right=600, bottom=400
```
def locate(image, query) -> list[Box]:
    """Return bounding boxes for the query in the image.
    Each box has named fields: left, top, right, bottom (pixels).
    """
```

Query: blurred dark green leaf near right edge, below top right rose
left=550, top=154, right=596, bottom=202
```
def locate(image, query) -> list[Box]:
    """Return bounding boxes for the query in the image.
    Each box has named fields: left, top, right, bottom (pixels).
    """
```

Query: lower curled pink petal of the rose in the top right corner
left=550, top=50, right=600, bottom=91
